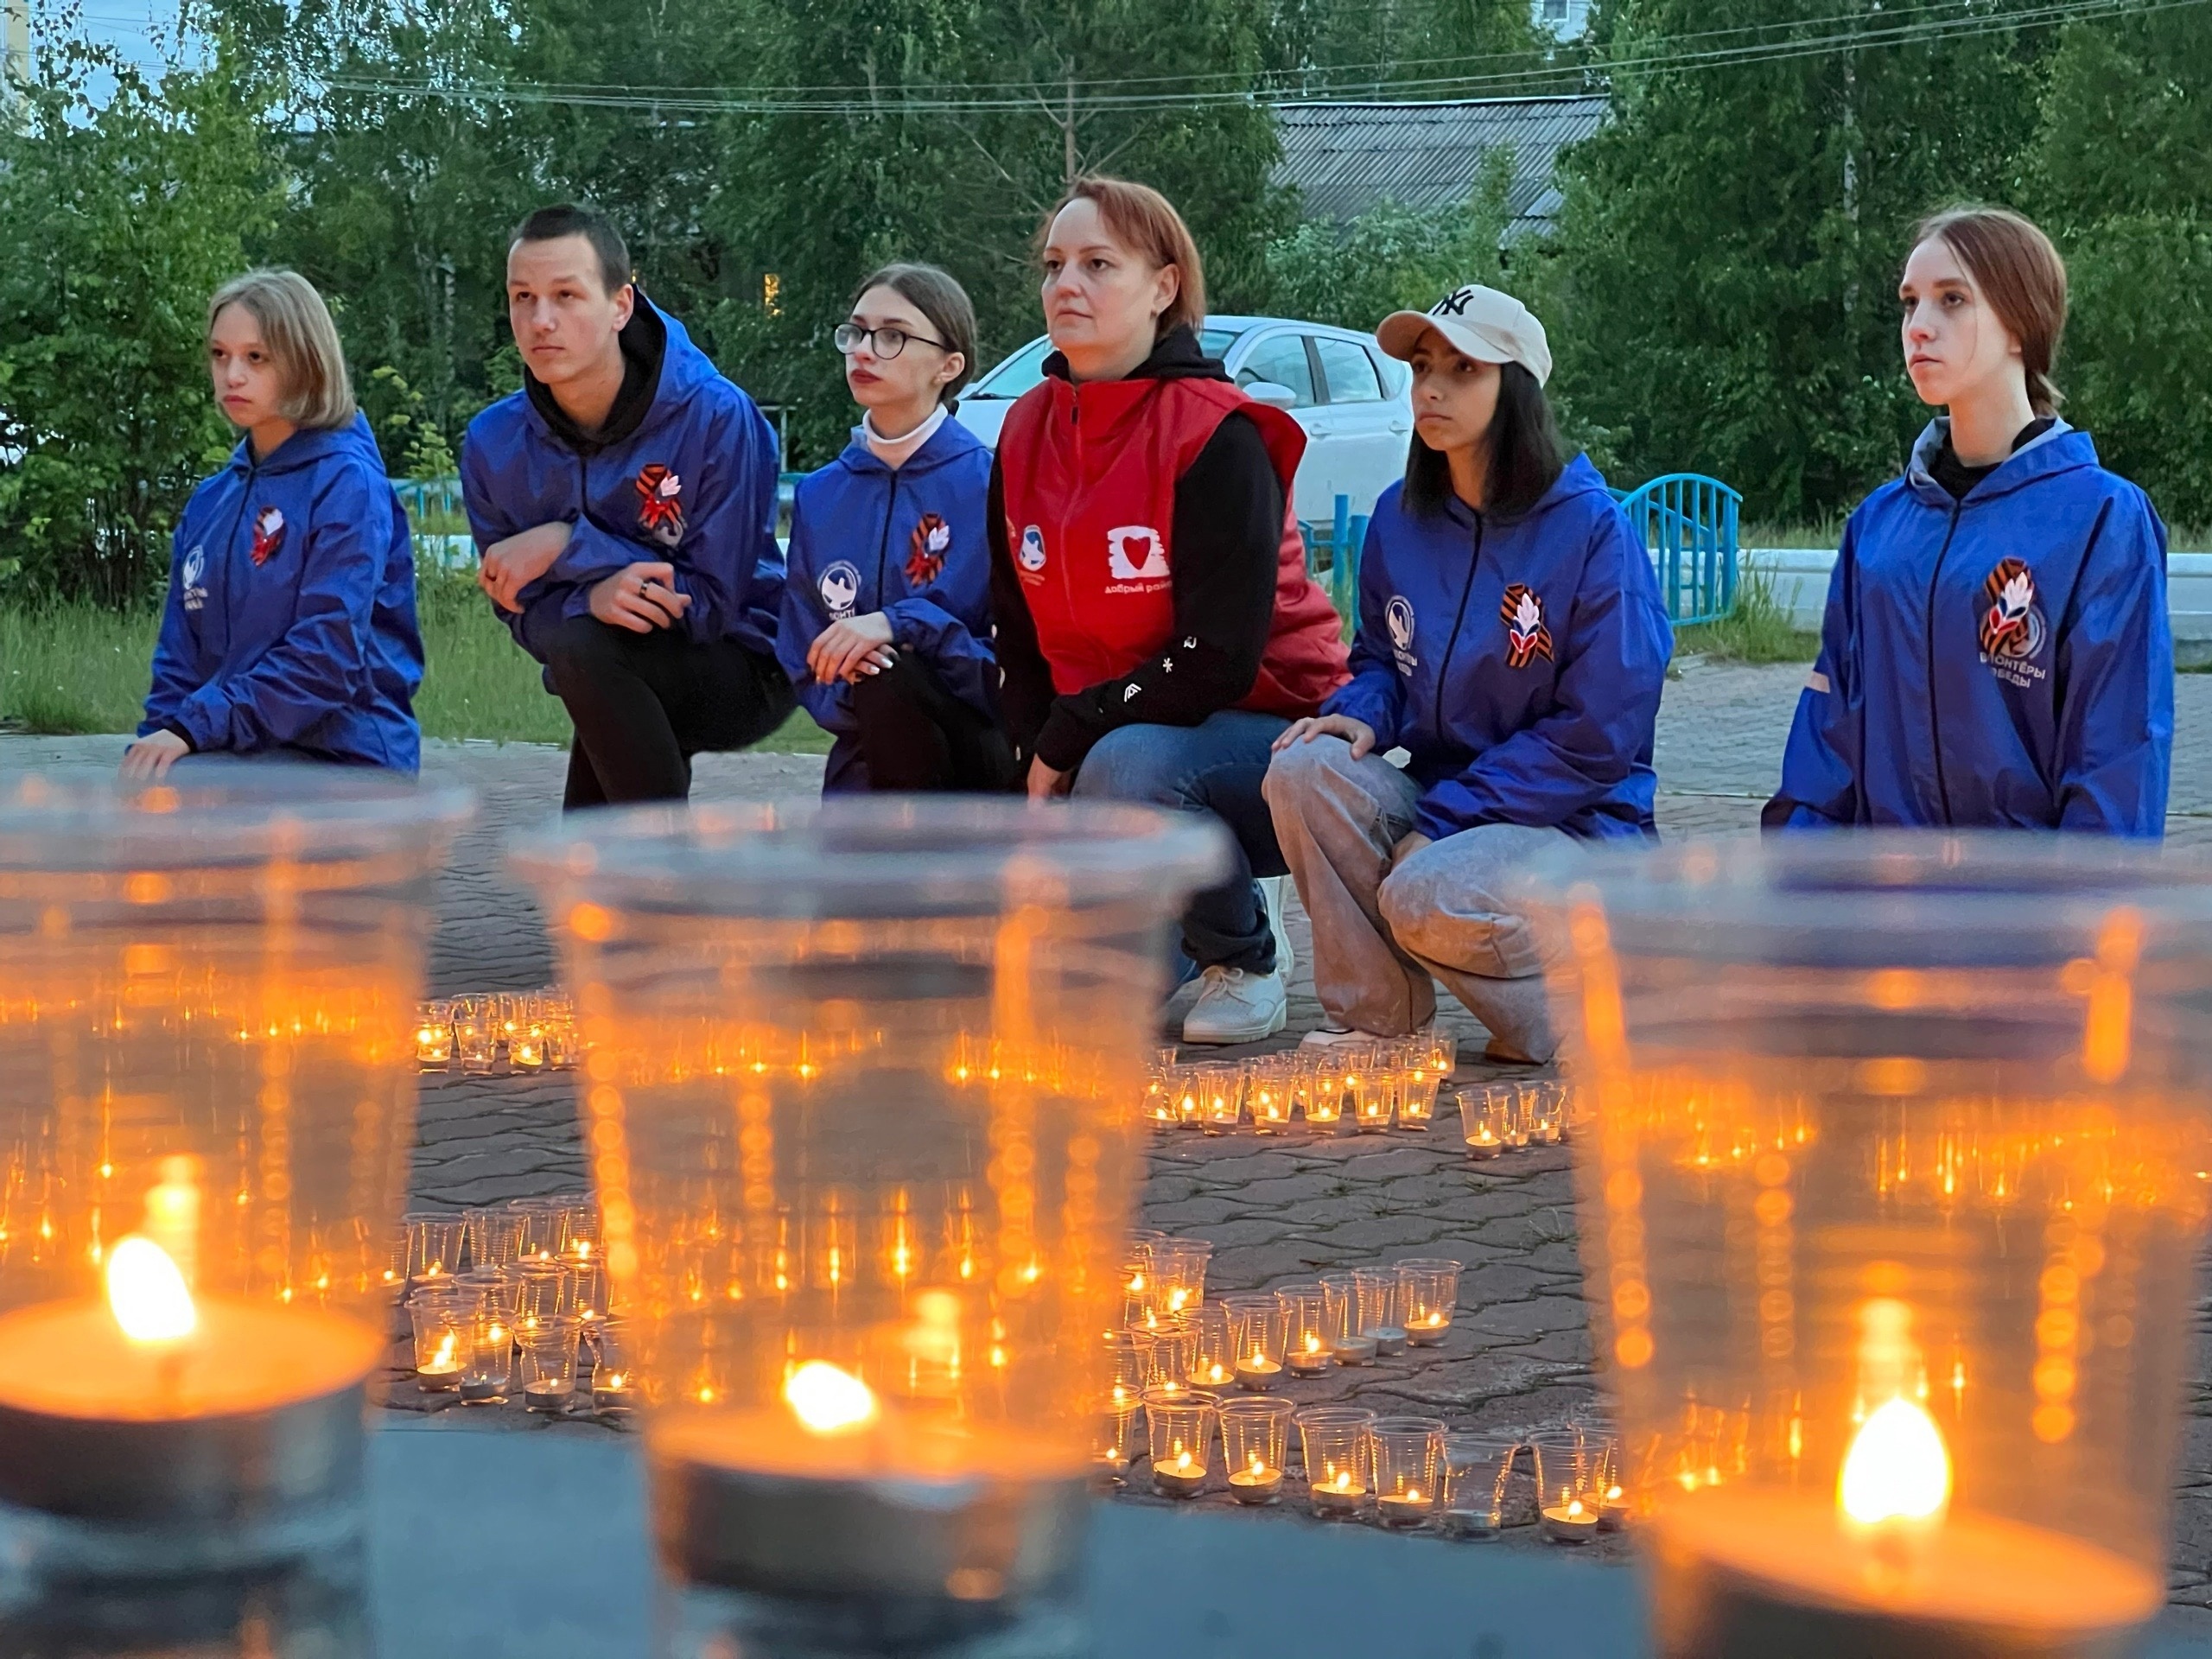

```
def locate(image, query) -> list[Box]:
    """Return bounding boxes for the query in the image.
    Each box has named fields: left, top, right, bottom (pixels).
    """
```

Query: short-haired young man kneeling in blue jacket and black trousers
left=460, top=206, right=791, bottom=810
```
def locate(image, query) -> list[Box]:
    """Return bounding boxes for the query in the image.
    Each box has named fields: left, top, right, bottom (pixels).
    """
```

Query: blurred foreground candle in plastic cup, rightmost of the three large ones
left=1531, top=836, right=2212, bottom=1659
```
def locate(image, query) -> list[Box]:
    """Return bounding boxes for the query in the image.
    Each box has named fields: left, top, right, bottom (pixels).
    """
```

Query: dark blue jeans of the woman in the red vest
left=1073, top=708, right=1289, bottom=973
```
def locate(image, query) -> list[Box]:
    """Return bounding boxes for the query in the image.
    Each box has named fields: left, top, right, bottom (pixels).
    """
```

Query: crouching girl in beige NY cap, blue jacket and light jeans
left=1265, top=285, right=1672, bottom=1062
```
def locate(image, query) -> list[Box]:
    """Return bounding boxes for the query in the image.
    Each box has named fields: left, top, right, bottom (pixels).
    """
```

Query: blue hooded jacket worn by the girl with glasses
left=777, top=420, right=998, bottom=791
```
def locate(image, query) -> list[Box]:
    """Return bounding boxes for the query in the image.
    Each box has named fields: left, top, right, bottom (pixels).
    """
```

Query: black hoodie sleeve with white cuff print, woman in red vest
left=1030, top=414, right=1283, bottom=772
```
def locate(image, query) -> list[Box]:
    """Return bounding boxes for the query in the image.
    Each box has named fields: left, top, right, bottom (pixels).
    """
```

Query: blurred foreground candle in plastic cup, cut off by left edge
left=0, top=766, right=467, bottom=1606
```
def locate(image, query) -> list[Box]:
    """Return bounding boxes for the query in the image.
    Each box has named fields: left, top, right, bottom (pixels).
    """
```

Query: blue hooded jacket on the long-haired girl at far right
left=1763, top=420, right=2174, bottom=836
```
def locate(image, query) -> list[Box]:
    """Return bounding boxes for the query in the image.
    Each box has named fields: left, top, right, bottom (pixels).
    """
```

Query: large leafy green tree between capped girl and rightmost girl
left=1544, top=0, right=2046, bottom=518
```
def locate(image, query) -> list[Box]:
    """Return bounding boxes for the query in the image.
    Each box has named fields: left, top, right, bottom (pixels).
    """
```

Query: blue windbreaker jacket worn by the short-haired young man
left=460, top=294, right=783, bottom=661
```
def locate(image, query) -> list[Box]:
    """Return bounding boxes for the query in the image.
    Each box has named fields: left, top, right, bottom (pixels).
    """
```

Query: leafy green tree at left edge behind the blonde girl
left=0, top=24, right=279, bottom=604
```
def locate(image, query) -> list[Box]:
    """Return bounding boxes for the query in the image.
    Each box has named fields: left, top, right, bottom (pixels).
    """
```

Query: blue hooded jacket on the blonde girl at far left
left=139, top=414, right=423, bottom=772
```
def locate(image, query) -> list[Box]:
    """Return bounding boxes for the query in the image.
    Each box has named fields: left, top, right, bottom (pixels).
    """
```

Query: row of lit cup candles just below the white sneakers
left=1144, top=1031, right=1460, bottom=1135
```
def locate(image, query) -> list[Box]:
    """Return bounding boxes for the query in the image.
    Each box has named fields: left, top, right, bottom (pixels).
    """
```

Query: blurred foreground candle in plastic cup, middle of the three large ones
left=518, top=798, right=1225, bottom=1659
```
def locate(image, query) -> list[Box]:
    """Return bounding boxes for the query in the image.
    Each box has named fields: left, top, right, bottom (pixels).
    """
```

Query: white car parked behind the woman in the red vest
left=956, top=316, right=1414, bottom=524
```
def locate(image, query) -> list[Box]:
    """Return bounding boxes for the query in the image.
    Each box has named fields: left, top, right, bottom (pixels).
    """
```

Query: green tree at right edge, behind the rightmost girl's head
left=2035, top=11, right=2212, bottom=524
